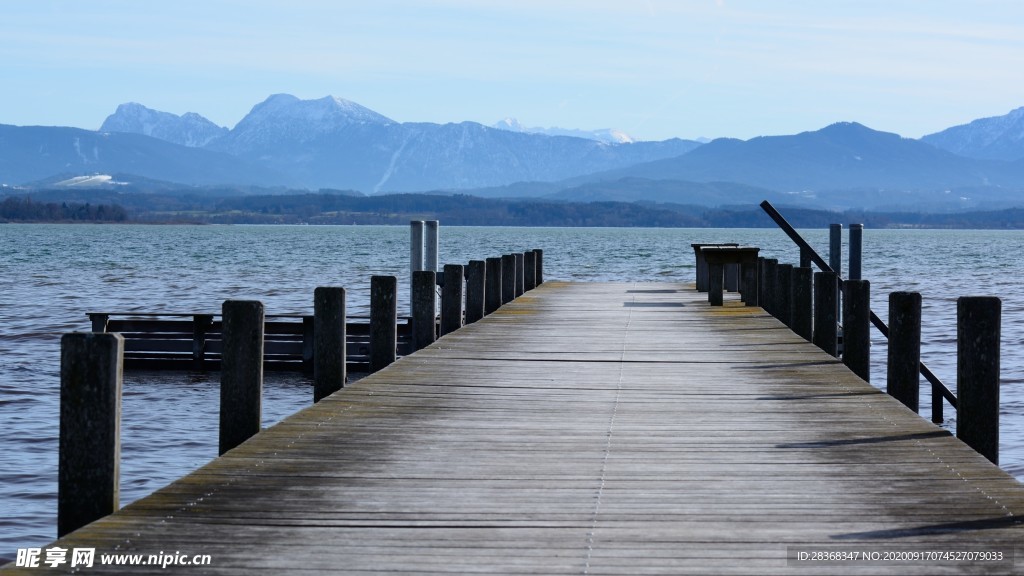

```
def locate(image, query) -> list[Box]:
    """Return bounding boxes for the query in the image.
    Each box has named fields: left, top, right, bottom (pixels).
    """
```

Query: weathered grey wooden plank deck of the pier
left=9, top=282, right=1024, bottom=575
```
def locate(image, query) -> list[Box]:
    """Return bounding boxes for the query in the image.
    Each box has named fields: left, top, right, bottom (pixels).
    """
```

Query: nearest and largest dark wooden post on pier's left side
left=57, top=332, right=124, bottom=537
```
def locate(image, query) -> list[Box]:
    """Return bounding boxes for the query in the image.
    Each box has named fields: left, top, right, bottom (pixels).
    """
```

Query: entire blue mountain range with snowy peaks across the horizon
left=6, top=94, right=1024, bottom=209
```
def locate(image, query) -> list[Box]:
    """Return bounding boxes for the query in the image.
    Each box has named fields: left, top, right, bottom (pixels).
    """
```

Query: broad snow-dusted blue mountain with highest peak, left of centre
left=209, top=94, right=700, bottom=193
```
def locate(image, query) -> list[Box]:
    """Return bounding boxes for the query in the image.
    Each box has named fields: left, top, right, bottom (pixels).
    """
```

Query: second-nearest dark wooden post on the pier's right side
left=886, top=292, right=921, bottom=412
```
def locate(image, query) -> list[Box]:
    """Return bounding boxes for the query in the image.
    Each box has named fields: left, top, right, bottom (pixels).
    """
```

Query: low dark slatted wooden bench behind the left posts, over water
left=87, top=312, right=413, bottom=374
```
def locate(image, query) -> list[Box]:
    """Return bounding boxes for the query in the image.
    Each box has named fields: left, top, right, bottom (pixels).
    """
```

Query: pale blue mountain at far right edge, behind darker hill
left=921, top=108, right=1024, bottom=160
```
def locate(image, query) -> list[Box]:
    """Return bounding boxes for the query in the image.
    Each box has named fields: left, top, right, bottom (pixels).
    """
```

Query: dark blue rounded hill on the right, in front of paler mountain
left=568, top=122, right=1024, bottom=193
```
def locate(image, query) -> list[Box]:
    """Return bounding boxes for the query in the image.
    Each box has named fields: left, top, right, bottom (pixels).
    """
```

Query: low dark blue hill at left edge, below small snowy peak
left=0, top=125, right=284, bottom=186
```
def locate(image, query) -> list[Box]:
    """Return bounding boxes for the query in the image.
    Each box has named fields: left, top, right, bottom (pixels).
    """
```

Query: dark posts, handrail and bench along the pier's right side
left=692, top=201, right=1001, bottom=464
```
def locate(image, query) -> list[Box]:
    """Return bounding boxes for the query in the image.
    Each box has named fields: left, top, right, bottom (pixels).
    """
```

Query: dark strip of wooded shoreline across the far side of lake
left=0, top=191, right=1024, bottom=230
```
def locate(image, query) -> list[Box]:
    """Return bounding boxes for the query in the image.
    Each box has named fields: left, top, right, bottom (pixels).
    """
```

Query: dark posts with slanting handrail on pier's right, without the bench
left=758, top=200, right=1001, bottom=464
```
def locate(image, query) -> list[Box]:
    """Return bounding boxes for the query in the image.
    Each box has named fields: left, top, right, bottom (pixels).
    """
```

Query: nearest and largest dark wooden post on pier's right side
left=956, top=296, right=1002, bottom=464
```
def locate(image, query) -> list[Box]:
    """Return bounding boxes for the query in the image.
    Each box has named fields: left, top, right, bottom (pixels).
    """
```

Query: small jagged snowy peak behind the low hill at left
left=99, top=102, right=227, bottom=148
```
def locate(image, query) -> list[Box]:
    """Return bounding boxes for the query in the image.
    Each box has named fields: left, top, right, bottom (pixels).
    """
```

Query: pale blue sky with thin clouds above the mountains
left=0, top=0, right=1024, bottom=139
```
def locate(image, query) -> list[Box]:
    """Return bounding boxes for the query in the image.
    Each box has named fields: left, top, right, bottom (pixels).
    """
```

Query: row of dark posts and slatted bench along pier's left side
left=57, top=240, right=544, bottom=537
